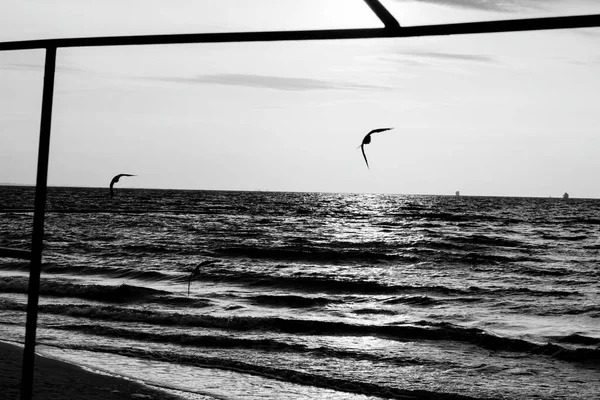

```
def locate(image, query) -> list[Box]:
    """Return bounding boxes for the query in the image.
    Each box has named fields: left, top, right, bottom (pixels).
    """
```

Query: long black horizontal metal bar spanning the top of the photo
left=0, top=14, right=600, bottom=51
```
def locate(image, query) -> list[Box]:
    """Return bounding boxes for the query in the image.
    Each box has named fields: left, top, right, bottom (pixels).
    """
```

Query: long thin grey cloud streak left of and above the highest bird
left=153, top=74, right=387, bottom=91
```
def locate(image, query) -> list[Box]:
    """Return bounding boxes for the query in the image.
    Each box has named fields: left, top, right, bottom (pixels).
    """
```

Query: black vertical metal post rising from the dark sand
left=21, top=47, right=56, bottom=400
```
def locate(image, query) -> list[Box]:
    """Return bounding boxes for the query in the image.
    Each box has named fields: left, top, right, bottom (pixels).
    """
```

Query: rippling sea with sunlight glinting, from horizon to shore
left=0, top=186, right=600, bottom=400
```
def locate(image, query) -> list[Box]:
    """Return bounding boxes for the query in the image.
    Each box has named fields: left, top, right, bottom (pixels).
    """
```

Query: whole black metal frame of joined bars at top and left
left=0, top=0, right=600, bottom=400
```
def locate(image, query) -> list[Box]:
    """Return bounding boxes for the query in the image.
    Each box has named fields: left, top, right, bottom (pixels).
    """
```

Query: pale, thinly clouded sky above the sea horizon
left=0, top=0, right=600, bottom=198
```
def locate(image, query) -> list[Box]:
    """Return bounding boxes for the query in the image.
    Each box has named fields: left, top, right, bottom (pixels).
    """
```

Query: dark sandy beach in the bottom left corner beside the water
left=0, top=342, right=188, bottom=400
